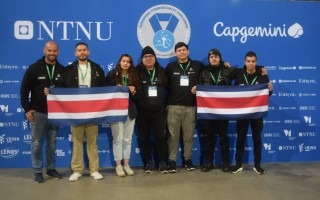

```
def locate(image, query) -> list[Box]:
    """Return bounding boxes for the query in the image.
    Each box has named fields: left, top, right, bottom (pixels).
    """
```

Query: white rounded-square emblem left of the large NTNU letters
left=14, top=21, right=33, bottom=40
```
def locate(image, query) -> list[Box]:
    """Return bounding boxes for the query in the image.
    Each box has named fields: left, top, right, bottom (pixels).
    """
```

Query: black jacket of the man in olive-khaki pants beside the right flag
left=165, top=59, right=203, bottom=106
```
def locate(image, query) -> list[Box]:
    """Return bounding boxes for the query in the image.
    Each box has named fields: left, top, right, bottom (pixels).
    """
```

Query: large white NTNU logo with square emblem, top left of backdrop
left=14, top=20, right=113, bottom=41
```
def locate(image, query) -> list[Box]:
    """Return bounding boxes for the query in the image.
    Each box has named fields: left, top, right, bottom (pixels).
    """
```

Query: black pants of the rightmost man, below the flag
left=236, top=118, right=263, bottom=164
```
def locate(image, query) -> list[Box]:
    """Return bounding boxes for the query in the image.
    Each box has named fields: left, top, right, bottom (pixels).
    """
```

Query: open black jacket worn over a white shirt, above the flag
left=63, top=60, right=106, bottom=88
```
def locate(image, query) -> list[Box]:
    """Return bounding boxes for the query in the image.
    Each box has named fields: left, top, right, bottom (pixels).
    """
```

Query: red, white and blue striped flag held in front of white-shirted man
left=47, top=86, right=129, bottom=126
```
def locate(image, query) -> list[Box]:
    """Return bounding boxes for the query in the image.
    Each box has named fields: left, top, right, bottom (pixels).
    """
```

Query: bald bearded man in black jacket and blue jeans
left=20, top=41, right=64, bottom=183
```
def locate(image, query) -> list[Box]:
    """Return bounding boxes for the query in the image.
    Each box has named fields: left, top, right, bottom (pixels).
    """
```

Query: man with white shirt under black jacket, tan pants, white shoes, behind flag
left=63, top=42, right=106, bottom=181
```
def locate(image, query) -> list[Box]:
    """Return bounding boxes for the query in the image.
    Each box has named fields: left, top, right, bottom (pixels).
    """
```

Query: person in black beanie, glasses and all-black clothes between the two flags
left=137, top=46, right=168, bottom=173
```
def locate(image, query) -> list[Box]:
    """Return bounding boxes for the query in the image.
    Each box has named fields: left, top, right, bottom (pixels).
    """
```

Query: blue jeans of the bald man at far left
left=30, top=112, right=58, bottom=173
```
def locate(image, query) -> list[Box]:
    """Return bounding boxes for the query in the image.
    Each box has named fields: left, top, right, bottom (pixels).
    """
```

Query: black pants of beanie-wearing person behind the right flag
left=203, top=120, right=229, bottom=165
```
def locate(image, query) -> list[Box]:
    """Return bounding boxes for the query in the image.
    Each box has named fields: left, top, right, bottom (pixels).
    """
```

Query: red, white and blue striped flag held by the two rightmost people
left=196, top=84, right=269, bottom=119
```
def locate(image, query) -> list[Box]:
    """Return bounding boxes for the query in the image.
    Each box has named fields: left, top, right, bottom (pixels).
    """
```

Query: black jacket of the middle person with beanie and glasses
left=136, top=65, right=168, bottom=112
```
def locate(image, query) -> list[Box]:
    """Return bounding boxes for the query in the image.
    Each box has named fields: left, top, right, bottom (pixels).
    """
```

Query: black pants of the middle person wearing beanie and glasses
left=136, top=110, right=167, bottom=165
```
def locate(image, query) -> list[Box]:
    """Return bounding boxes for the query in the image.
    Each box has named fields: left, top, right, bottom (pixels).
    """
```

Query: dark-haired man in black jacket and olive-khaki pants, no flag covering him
left=166, top=42, right=203, bottom=172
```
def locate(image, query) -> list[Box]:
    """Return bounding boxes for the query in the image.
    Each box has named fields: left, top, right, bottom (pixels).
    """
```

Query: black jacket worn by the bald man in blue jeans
left=20, top=57, right=64, bottom=114
